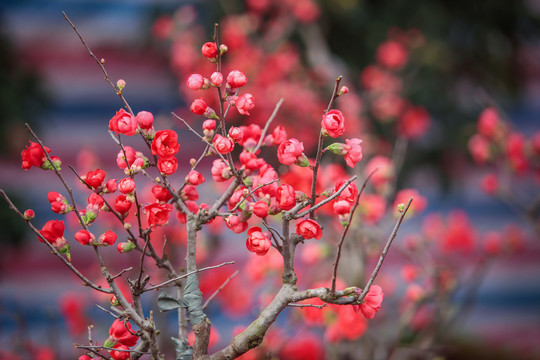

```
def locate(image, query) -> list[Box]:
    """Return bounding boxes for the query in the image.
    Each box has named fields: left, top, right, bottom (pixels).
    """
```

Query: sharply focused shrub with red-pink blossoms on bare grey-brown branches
left=1, top=12, right=413, bottom=359
